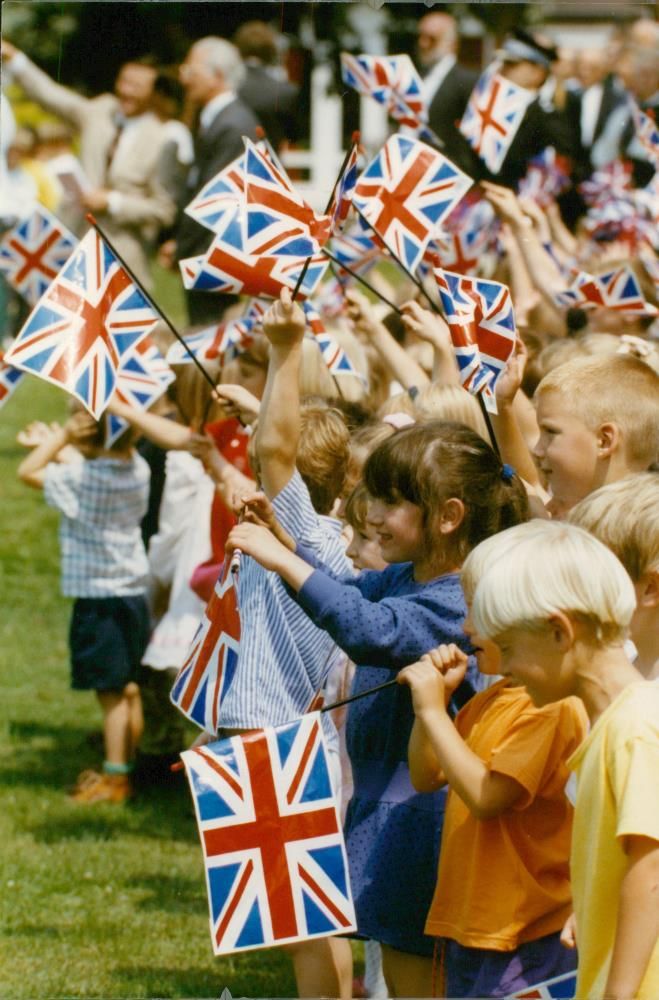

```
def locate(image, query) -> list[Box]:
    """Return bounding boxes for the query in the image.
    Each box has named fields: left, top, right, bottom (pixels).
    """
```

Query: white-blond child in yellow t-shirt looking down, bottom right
left=471, top=522, right=659, bottom=1000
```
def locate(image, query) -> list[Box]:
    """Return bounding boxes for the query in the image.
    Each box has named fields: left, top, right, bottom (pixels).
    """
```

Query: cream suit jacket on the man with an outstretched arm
left=12, top=57, right=176, bottom=285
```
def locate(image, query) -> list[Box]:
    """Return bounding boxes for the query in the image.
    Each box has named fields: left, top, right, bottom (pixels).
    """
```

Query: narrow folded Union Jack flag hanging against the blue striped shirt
left=170, top=559, right=240, bottom=736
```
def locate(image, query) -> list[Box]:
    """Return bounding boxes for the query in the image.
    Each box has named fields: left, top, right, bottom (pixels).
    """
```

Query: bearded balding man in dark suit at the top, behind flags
left=416, top=12, right=478, bottom=159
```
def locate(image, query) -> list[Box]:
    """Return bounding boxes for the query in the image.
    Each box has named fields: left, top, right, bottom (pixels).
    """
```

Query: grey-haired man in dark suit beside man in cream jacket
left=165, top=37, right=258, bottom=325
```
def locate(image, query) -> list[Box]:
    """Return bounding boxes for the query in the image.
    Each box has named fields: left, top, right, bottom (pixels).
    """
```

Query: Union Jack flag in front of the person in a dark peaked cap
left=460, top=64, right=535, bottom=174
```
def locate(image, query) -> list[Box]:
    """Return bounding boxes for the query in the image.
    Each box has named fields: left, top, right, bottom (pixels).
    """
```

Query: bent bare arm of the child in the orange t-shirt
left=398, top=645, right=524, bottom=819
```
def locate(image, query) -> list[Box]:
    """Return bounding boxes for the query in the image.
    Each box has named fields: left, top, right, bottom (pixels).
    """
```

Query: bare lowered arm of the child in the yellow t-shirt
left=603, top=836, right=659, bottom=1000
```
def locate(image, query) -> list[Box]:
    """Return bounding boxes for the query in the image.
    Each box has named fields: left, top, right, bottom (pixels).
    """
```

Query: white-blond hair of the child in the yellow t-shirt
left=463, top=520, right=636, bottom=643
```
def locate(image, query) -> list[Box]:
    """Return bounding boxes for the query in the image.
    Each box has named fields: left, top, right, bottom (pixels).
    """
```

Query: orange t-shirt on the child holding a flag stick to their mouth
left=426, top=680, right=588, bottom=951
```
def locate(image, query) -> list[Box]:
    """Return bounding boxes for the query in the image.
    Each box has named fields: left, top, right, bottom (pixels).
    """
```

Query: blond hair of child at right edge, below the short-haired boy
left=568, top=472, right=659, bottom=583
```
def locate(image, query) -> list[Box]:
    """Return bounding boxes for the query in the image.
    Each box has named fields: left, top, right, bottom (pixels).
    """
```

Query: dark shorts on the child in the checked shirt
left=69, top=594, right=150, bottom=691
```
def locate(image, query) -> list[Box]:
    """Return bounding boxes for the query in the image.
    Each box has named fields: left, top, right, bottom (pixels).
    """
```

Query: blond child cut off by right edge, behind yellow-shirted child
left=568, top=472, right=659, bottom=680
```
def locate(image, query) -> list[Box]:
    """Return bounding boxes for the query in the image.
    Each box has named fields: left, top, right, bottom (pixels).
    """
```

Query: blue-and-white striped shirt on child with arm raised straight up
left=222, top=470, right=352, bottom=747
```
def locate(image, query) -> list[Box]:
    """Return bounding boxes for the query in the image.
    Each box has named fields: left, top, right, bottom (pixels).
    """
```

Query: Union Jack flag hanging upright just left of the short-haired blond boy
left=435, top=268, right=517, bottom=413
